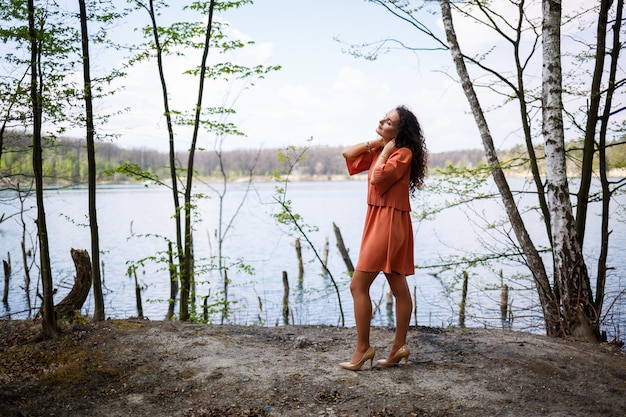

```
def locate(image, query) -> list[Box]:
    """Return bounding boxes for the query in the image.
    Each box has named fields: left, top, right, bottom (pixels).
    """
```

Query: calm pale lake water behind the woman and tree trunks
left=0, top=180, right=626, bottom=334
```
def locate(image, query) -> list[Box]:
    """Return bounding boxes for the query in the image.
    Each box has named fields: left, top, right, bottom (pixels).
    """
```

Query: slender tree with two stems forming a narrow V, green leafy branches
left=130, top=0, right=279, bottom=320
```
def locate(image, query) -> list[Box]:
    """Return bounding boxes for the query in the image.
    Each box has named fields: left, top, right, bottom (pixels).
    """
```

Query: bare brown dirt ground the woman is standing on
left=0, top=319, right=626, bottom=417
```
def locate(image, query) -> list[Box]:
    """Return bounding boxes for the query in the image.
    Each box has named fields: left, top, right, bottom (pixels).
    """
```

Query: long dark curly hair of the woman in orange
left=395, top=105, right=428, bottom=196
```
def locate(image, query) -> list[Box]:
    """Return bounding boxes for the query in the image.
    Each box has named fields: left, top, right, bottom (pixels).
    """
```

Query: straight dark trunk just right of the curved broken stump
left=78, top=0, right=104, bottom=321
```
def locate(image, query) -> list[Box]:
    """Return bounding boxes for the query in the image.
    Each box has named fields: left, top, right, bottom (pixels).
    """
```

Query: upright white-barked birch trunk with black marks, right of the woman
left=542, top=0, right=597, bottom=335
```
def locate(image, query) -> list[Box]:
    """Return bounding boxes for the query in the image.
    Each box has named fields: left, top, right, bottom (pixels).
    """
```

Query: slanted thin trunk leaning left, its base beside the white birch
left=439, top=0, right=560, bottom=335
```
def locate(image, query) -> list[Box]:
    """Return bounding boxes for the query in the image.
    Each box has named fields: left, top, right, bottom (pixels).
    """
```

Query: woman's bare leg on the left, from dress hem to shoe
left=350, top=271, right=378, bottom=363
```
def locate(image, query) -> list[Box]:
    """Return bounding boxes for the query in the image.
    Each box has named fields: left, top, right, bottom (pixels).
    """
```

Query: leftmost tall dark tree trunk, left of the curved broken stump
left=28, top=0, right=58, bottom=339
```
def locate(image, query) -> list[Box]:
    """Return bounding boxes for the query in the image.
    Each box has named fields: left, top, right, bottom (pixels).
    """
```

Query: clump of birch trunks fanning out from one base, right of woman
left=356, top=0, right=623, bottom=338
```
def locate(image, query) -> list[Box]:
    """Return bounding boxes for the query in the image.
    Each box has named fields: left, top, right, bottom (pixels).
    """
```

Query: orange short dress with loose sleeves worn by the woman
left=346, top=148, right=415, bottom=275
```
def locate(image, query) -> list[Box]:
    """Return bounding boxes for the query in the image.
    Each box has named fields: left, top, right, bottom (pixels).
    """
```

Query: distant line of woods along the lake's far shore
left=0, top=135, right=626, bottom=185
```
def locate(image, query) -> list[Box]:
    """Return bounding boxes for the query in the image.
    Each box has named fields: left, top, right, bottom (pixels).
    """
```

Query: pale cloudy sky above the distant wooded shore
left=70, top=0, right=588, bottom=152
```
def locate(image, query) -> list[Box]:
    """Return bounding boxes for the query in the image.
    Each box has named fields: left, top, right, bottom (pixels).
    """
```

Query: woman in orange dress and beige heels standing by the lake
left=339, top=106, right=428, bottom=371
